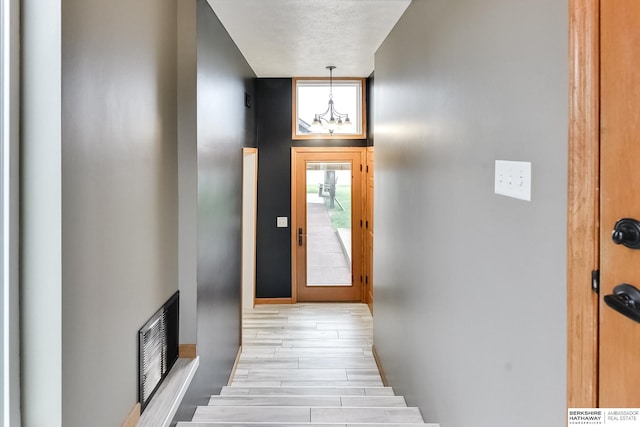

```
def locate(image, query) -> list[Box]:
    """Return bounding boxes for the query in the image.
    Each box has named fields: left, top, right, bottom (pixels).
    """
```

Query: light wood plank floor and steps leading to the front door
left=178, top=303, right=437, bottom=427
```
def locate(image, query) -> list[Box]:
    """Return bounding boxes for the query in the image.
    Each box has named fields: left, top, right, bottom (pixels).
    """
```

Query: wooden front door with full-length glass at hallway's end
left=291, top=147, right=364, bottom=301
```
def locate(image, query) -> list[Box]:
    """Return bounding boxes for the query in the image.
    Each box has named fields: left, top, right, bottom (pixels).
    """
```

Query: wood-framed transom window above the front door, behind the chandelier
left=292, top=78, right=366, bottom=139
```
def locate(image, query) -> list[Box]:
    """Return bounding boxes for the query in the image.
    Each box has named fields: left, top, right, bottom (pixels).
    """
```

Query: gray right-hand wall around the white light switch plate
left=374, top=0, right=568, bottom=427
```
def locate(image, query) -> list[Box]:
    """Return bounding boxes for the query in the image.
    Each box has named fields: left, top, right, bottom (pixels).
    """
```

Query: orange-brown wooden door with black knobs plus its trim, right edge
left=567, top=0, right=640, bottom=408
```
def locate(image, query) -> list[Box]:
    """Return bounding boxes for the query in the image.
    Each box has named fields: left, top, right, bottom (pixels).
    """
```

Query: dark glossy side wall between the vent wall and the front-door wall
left=174, top=0, right=255, bottom=422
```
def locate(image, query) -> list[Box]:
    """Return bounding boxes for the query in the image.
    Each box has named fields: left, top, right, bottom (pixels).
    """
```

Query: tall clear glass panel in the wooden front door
left=306, top=162, right=352, bottom=286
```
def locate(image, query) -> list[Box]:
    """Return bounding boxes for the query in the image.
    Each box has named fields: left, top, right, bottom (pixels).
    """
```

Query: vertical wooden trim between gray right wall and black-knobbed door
left=567, top=0, right=600, bottom=408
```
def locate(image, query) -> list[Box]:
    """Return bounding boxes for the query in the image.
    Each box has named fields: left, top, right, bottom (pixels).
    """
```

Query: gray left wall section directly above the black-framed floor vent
left=62, top=0, right=178, bottom=426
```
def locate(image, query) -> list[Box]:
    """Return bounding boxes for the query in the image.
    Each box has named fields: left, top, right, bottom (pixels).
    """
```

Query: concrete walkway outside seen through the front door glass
left=307, top=194, right=351, bottom=286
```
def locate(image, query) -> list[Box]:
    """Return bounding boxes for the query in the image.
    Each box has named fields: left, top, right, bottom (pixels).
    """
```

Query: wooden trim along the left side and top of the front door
left=291, top=147, right=366, bottom=304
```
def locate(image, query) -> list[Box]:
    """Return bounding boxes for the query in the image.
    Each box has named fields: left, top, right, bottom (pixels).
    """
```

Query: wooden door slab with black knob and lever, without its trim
left=598, top=0, right=640, bottom=408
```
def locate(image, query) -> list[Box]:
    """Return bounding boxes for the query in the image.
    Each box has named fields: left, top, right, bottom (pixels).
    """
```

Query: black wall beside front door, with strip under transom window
left=256, top=78, right=367, bottom=298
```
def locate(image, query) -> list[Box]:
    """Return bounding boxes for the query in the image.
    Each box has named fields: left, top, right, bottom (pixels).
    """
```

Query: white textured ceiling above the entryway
left=208, top=0, right=411, bottom=77
